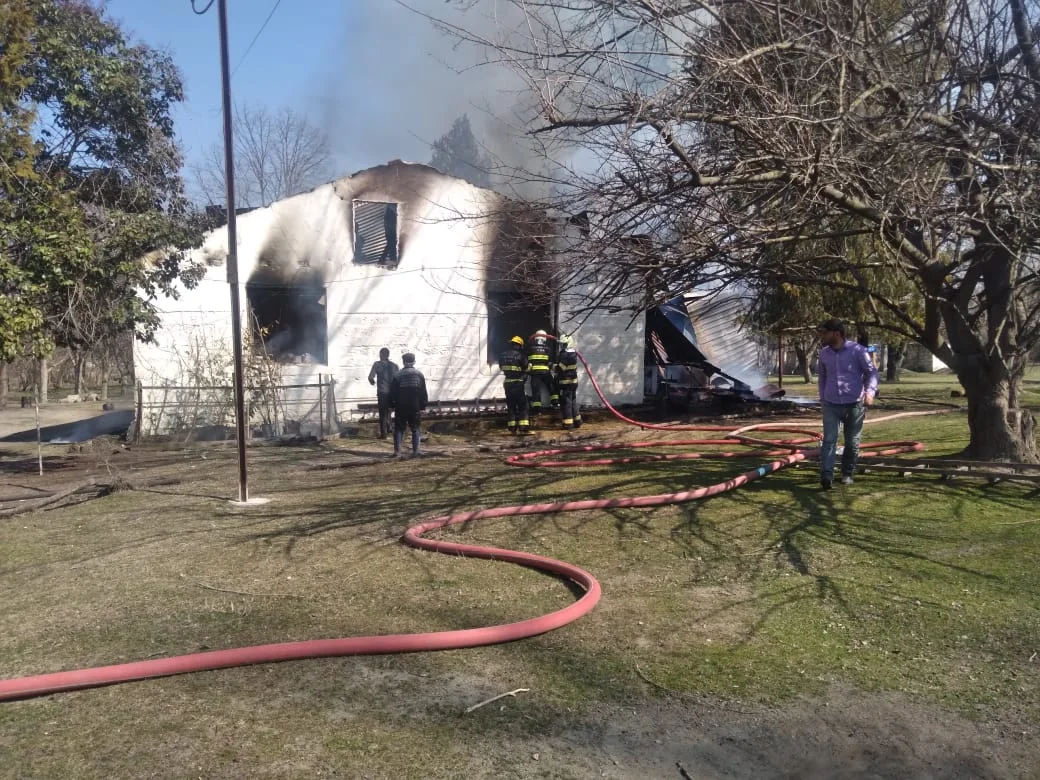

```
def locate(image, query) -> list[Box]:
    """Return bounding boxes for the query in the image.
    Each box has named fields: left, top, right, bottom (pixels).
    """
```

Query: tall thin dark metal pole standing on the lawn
left=216, top=0, right=250, bottom=503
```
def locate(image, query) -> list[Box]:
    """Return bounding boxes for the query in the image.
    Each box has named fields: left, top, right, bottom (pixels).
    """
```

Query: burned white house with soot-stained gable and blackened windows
left=134, top=160, right=644, bottom=433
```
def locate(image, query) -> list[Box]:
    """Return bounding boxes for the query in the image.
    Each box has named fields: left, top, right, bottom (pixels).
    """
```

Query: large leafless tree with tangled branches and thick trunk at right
left=426, top=0, right=1040, bottom=461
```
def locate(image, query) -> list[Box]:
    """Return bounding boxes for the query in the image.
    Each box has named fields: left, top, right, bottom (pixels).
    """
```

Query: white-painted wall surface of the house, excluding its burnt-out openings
left=134, top=163, right=643, bottom=431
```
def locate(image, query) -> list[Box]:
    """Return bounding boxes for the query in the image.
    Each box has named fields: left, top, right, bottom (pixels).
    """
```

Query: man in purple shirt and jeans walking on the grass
left=816, top=319, right=878, bottom=490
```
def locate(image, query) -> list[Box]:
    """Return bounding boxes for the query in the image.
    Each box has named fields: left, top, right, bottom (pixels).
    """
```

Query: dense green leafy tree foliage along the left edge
left=0, top=0, right=202, bottom=368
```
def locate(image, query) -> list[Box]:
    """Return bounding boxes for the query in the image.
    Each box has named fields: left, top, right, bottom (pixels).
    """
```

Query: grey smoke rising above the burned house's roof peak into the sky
left=320, top=0, right=548, bottom=198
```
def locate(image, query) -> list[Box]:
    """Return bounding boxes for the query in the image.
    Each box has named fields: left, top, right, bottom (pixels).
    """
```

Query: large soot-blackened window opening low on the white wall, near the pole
left=245, top=275, right=329, bottom=364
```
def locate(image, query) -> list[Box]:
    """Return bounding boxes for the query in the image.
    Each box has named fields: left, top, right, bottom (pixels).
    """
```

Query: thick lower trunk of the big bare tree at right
left=958, top=371, right=1040, bottom=463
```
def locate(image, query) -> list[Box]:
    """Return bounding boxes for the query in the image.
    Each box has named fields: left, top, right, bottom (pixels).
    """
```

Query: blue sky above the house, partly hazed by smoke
left=105, top=0, right=532, bottom=201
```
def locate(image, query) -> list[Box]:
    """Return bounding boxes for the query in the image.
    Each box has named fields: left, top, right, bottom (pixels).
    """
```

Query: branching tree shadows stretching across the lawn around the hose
left=14, top=436, right=1022, bottom=686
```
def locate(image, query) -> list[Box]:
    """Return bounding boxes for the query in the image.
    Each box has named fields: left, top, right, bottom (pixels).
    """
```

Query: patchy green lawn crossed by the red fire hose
left=0, top=376, right=1040, bottom=778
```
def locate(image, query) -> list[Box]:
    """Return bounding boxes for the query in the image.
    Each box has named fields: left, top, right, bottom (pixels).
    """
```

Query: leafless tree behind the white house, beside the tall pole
left=191, top=105, right=334, bottom=208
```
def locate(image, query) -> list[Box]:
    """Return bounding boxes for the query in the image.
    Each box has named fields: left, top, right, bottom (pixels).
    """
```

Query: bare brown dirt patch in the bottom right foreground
left=530, top=687, right=1036, bottom=780
